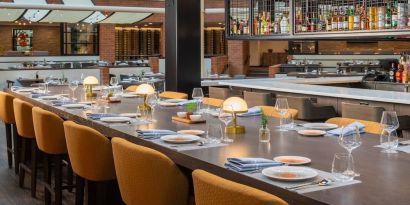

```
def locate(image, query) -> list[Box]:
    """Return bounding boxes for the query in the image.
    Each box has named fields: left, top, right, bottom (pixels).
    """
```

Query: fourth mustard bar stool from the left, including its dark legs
left=63, top=121, right=118, bottom=205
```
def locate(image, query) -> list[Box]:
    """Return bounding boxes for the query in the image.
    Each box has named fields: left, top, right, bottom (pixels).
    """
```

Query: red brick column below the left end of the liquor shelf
left=228, top=40, right=249, bottom=75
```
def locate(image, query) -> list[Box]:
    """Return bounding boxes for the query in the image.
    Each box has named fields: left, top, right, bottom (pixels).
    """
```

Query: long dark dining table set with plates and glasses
left=6, top=86, right=410, bottom=205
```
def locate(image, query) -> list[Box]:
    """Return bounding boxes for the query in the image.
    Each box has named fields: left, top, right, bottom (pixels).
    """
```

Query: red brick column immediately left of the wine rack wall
left=100, top=24, right=115, bottom=62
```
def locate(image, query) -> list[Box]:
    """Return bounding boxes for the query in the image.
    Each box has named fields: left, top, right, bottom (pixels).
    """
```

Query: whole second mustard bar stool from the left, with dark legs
left=13, top=98, right=37, bottom=197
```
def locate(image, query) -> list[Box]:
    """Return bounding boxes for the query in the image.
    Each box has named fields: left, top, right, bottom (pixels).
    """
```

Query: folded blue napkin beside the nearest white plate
left=225, top=158, right=282, bottom=172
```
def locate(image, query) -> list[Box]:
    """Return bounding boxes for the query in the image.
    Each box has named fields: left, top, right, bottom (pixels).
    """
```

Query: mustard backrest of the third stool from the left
left=32, top=107, right=67, bottom=154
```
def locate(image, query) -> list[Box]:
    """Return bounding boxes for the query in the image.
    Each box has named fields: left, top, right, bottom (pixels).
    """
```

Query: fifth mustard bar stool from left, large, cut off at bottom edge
left=112, top=138, right=189, bottom=205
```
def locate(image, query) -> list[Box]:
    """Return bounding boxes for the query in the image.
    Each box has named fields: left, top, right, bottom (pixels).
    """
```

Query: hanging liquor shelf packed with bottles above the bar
left=226, top=0, right=410, bottom=39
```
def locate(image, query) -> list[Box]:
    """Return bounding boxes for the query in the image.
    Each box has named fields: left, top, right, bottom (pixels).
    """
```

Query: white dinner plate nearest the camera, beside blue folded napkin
left=262, top=166, right=318, bottom=181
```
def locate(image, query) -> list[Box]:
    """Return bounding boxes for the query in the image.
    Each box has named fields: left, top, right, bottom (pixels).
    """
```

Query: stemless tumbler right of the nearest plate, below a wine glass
left=332, top=153, right=355, bottom=182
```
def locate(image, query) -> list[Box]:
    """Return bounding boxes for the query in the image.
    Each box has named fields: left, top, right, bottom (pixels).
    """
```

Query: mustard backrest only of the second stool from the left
left=13, top=98, right=36, bottom=138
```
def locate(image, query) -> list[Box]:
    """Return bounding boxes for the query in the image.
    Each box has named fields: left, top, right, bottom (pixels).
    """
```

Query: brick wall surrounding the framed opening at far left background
left=0, top=24, right=61, bottom=55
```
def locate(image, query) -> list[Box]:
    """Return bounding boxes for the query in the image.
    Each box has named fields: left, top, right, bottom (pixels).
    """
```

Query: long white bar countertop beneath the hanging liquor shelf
left=218, top=77, right=410, bottom=105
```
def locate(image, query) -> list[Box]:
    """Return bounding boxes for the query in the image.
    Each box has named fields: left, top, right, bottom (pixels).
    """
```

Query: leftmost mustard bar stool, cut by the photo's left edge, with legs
left=0, top=91, right=18, bottom=170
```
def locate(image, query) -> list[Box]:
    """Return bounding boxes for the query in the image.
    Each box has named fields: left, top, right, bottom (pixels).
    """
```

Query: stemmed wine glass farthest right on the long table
left=380, top=111, right=399, bottom=153
